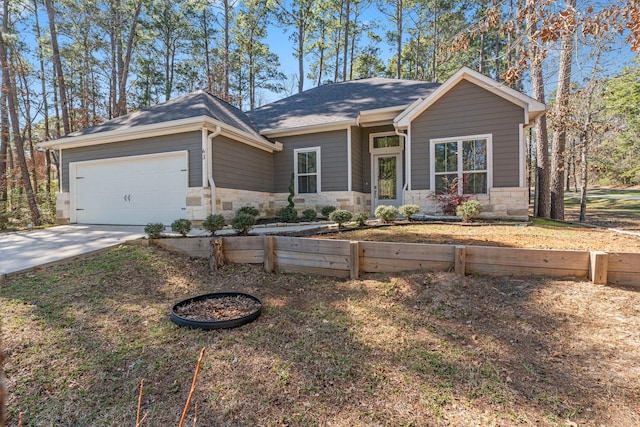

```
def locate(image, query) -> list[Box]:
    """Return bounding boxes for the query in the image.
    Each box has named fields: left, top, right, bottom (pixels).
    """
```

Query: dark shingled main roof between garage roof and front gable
left=248, top=78, right=440, bottom=136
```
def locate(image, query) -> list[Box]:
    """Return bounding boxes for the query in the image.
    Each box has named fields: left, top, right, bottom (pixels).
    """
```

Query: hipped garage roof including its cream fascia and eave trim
left=40, top=90, right=278, bottom=150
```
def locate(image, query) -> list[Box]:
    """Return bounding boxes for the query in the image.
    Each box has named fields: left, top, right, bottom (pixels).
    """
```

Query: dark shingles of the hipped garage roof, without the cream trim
left=68, top=90, right=262, bottom=138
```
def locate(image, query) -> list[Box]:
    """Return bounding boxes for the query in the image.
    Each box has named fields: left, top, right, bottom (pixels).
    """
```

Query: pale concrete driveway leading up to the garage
left=0, top=224, right=145, bottom=279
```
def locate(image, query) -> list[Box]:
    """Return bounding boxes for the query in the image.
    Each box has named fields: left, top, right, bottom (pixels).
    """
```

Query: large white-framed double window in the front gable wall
left=431, top=135, right=491, bottom=194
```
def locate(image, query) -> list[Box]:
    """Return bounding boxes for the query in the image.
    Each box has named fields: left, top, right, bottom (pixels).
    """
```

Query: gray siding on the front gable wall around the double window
left=411, top=80, right=524, bottom=190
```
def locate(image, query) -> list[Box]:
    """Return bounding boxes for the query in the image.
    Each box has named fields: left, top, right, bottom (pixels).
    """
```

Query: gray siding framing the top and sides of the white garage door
left=62, top=131, right=202, bottom=191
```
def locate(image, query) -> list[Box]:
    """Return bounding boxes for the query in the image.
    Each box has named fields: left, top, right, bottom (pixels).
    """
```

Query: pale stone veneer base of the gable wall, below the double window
left=404, top=187, right=529, bottom=220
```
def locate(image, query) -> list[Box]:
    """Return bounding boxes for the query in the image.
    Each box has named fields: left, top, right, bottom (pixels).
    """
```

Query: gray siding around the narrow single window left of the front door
left=273, top=129, right=347, bottom=193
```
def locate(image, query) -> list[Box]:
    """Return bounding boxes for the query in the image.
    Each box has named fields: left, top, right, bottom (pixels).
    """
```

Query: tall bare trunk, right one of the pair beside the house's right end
left=551, top=0, right=576, bottom=220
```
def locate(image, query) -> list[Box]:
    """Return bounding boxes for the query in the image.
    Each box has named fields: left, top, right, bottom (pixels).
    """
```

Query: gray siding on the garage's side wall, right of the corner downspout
left=211, top=136, right=273, bottom=192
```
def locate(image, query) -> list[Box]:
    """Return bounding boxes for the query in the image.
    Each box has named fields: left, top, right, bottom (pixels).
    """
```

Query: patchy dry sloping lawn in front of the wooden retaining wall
left=0, top=244, right=640, bottom=427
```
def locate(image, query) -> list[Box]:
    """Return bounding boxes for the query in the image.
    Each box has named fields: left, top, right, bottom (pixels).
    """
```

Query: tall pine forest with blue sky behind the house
left=0, top=0, right=640, bottom=230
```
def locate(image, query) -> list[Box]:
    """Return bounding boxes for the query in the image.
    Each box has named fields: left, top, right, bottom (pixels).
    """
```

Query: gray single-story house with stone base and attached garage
left=40, top=68, right=546, bottom=224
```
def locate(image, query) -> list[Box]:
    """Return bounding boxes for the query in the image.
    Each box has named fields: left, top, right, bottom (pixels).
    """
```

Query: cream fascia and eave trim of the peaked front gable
left=393, top=67, right=547, bottom=129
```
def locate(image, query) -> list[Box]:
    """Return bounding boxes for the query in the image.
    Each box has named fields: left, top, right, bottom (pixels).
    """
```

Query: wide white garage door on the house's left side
left=69, top=151, right=188, bottom=225
